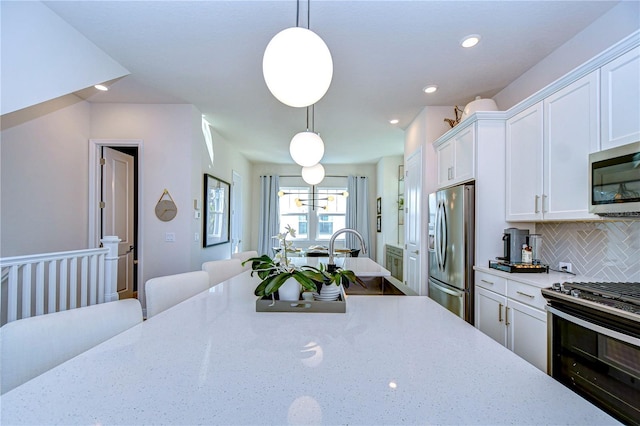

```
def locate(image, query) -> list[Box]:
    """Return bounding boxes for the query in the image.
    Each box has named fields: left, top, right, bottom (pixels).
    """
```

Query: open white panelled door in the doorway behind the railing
left=102, top=147, right=135, bottom=299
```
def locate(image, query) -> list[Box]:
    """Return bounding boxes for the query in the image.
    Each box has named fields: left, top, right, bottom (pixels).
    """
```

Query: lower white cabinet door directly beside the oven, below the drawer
left=505, top=299, right=547, bottom=373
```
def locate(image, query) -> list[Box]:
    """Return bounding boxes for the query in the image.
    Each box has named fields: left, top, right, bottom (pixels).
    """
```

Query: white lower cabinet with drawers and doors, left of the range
left=475, top=271, right=547, bottom=373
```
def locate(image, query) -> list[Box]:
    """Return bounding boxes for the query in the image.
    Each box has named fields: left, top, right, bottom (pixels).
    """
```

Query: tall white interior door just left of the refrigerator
left=404, top=150, right=424, bottom=295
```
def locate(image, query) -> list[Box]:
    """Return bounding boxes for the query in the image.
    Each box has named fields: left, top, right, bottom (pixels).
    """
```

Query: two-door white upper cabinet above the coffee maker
left=506, top=71, right=598, bottom=221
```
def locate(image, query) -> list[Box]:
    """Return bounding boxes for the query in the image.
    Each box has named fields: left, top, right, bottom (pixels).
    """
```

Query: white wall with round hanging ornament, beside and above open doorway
left=91, top=104, right=198, bottom=282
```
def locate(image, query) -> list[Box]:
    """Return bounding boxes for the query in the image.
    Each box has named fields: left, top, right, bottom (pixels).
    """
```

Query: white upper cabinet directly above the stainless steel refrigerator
left=436, top=122, right=476, bottom=188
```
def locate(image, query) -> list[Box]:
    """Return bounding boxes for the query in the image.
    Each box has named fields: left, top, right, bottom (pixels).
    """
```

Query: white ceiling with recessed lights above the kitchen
left=44, top=0, right=617, bottom=164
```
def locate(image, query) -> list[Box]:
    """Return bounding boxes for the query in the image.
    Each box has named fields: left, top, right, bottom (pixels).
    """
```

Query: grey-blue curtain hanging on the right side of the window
left=344, top=176, right=371, bottom=257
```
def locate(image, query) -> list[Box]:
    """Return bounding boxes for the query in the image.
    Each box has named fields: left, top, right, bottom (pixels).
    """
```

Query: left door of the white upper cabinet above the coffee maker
left=506, top=102, right=544, bottom=221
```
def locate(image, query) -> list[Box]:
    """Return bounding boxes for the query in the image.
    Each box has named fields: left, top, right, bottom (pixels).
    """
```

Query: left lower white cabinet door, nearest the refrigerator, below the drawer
left=475, top=287, right=507, bottom=346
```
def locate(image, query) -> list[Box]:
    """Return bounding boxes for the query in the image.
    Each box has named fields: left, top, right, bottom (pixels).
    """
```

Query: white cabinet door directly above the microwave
left=600, top=47, right=640, bottom=149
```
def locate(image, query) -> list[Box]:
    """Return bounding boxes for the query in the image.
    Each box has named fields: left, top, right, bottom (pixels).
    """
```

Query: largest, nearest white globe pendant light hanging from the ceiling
left=262, top=0, right=333, bottom=107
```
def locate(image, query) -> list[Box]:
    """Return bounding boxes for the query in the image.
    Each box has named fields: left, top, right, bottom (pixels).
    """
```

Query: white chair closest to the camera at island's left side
left=0, top=299, right=142, bottom=393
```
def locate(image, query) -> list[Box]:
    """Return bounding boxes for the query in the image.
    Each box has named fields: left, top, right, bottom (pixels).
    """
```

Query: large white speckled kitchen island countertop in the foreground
left=0, top=271, right=617, bottom=425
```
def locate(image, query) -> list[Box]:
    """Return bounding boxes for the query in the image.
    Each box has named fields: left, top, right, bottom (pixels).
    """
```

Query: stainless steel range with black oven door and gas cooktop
left=542, top=282, right=640, bottom=425
